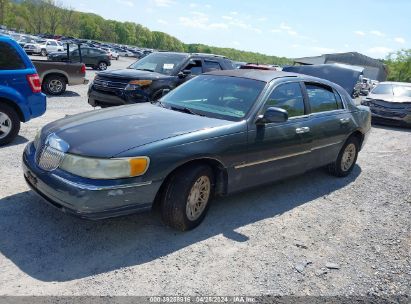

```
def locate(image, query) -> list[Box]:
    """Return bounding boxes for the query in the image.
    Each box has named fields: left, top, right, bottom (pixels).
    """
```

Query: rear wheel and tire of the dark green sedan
left=328, top=136, right=360, bottom=177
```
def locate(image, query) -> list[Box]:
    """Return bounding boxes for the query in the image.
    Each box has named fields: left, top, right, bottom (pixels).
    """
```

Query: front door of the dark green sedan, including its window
left=235, top=82, right=312, bottom=190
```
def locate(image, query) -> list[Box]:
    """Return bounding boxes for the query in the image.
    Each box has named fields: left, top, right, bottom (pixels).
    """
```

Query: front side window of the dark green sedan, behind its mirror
left=264, top=82, right=304, bottom=117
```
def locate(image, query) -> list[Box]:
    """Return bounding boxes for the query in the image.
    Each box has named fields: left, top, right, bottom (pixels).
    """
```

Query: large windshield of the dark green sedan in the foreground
left=160, top=75, right=266, bottom=121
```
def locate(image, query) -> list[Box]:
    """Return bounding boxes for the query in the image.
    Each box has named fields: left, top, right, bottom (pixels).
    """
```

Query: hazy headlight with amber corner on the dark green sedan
left=59, top=154, right=150, bottom=179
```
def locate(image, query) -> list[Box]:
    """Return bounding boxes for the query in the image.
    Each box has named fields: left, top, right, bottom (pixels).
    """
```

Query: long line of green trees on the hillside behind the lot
left=0, top=0, right=292, bottom=65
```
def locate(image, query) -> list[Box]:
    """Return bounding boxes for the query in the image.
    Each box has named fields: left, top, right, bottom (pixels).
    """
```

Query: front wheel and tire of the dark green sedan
left=160, top=165, right=214, bottom=231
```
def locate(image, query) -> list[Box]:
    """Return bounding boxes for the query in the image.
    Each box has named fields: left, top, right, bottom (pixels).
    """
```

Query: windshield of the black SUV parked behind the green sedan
left=129, top=53, right=188, bottom=75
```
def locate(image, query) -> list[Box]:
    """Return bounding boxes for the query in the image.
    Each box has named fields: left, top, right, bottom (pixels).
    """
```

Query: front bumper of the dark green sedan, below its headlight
left=23, top=143, right=161, bottom=220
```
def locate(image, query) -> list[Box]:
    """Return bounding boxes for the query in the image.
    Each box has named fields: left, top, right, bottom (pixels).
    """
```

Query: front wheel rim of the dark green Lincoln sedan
left=186, top=176, right=211, bottom=221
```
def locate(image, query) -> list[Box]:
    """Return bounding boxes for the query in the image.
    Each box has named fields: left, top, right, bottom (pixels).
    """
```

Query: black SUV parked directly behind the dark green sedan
left=88, top=52, right=234, bottom=107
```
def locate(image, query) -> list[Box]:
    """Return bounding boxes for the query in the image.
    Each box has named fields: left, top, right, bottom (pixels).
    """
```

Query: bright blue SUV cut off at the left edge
left=0, top=35, right=46, bottom=146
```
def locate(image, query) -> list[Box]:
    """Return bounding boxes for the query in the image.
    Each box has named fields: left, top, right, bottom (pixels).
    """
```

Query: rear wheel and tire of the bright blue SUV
left=0, top=104, right=20, bottom=146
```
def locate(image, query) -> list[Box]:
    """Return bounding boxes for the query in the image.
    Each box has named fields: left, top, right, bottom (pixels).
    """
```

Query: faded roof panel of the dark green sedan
left=205, top=69, right=300, bottom=82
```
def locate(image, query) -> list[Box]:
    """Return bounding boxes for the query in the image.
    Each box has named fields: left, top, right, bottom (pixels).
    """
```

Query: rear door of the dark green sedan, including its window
left=304, top=82, right=354, bottom=168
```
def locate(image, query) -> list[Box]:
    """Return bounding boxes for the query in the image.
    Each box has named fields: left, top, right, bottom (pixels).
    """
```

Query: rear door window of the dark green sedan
left=305, top=84, right=338, bottom=113
